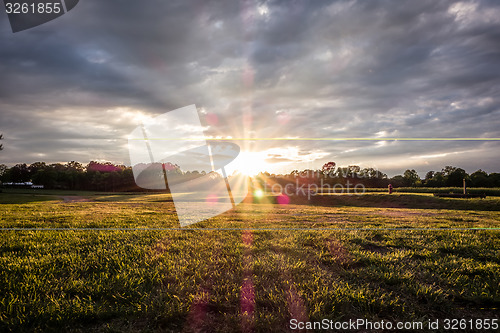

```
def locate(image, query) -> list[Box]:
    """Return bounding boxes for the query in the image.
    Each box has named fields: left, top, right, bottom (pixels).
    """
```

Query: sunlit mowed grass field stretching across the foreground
left=0, top=191, right=500, bottom=332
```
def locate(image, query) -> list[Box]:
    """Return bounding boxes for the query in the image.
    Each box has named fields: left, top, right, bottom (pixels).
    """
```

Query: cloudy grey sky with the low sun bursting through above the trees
left=0, top=0, right=500, bottom=176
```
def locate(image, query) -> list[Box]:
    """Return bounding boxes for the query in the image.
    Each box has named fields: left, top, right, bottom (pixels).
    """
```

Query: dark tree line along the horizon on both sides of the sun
left=0, top=161, right=500, bottom=192
